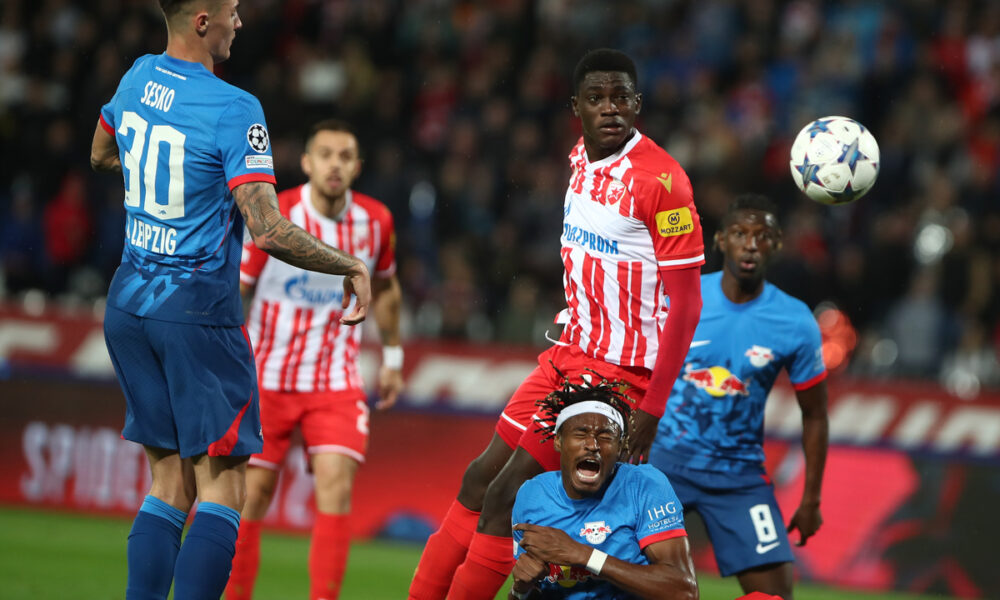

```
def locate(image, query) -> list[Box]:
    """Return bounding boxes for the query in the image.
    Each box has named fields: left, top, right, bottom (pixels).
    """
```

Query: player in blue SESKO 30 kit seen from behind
left=90, top=0, right=371, bottom=600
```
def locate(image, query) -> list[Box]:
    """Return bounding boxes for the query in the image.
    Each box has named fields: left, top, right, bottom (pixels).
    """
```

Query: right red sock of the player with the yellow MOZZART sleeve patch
left=448, top=533, right=516, bottom=600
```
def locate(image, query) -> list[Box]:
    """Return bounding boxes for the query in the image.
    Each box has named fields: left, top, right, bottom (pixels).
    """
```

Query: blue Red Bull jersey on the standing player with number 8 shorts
left=651, top=271, right=826, bottom=473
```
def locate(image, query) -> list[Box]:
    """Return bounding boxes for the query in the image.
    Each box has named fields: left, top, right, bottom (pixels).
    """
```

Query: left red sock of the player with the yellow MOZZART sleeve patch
left=408, top=500, right=482, bottom=600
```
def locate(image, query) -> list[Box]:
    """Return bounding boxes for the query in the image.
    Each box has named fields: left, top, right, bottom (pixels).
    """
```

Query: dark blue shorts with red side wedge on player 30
left=104, top=306, right=264, bottom=458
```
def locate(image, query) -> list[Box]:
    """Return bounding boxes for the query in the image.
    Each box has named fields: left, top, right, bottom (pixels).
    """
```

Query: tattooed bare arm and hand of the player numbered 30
left=233, top=181, right=372, bottom=325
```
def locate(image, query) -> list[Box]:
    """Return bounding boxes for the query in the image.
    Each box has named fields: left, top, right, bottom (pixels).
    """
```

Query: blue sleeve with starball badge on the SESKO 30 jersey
left=216, top=93, right=276, bottom=190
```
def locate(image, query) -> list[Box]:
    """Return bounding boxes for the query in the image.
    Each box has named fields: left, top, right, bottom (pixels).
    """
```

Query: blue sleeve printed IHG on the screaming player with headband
left=635, top=465, right=687, bottom=548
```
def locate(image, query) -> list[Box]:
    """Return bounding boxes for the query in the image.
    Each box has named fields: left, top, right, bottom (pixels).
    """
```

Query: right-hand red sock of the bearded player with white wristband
left=310, top=513, right=351, bottom=600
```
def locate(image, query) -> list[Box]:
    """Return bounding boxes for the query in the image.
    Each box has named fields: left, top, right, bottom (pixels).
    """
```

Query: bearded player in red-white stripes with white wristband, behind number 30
left=226, top=119, right=403, bottom=600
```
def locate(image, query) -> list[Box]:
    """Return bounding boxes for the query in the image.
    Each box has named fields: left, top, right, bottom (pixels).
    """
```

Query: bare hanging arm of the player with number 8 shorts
left=788, top=381, right=830, bottom=546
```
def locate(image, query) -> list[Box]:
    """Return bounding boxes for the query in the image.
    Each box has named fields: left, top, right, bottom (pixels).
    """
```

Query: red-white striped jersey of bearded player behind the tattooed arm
left=240, top=183, right=396, bottom=392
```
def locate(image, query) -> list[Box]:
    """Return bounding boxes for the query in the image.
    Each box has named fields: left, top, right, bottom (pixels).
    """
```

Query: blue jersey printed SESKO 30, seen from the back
left=101, top=54, right=275, bottom=326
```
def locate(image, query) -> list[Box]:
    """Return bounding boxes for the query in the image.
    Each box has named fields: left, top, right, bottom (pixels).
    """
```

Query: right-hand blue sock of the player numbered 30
left=173, top=502, right=240, bottom=600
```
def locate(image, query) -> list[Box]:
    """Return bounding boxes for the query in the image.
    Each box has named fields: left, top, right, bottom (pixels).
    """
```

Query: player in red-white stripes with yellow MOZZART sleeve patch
left=410, top=49, right=704, bottom=600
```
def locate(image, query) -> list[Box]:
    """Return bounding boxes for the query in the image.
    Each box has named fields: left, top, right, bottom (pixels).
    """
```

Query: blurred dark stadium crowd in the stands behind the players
left=0, top=0, right=1000, bottom=396
